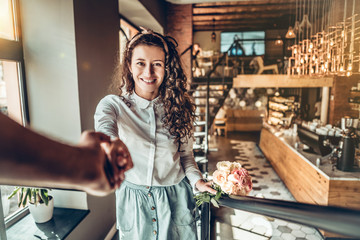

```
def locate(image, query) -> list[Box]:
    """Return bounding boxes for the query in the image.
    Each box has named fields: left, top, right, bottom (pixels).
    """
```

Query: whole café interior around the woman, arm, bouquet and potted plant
left=0, top=0, right=360, bottom=240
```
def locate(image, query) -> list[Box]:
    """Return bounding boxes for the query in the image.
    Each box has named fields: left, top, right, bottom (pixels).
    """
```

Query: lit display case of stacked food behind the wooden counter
left=267, top=96, right=300, bottom=127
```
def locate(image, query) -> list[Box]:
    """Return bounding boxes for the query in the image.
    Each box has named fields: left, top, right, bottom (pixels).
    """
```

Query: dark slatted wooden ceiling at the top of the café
left=193, top=0, right=302, bottom=31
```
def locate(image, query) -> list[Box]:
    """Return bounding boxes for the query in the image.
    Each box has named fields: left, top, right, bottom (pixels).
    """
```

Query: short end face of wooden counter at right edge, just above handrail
left=328, top=180, right=360, bottom=209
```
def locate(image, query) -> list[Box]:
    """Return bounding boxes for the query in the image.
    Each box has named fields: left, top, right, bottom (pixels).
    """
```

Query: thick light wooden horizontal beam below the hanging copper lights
left=233, top=74, right=333, bottom=88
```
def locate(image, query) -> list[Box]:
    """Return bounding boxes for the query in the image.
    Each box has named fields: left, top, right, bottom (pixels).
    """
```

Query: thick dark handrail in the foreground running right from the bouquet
left=219, top=196, right=360, bottom=238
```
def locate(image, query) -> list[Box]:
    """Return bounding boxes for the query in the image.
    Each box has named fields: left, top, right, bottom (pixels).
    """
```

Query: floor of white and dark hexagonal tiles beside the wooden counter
left=208, top=133, right=323, bottom=240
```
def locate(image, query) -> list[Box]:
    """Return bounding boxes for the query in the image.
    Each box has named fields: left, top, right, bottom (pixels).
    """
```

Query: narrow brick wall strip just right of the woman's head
left=165, top=3, right=193, bottom=79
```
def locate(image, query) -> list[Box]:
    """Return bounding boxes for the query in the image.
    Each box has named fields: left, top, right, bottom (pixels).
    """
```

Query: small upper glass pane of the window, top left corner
left=0, top=0, right=15, bottom=40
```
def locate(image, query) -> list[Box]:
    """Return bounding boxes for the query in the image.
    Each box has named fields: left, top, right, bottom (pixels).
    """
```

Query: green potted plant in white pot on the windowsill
left=8, top=187, right=54, bottom=223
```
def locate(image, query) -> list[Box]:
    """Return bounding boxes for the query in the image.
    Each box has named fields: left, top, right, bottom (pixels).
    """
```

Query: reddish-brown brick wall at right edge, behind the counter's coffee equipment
left=329, top=74, right=360, bottom=124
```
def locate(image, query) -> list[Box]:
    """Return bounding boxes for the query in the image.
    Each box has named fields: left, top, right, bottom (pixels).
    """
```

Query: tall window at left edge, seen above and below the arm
left=0, top=0, right=28, bottom=234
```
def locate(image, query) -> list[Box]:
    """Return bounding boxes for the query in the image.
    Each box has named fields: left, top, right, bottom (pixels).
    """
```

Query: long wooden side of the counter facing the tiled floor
left=260, top=128, right=329, bottom=205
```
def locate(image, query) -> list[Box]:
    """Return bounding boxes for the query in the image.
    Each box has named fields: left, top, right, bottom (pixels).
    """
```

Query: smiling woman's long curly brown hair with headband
left=113, top=30, right=195, bottom=150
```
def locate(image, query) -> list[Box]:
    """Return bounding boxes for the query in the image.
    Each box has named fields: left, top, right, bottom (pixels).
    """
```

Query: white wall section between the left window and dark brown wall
left=20, top=0, right=81, bottom=143
